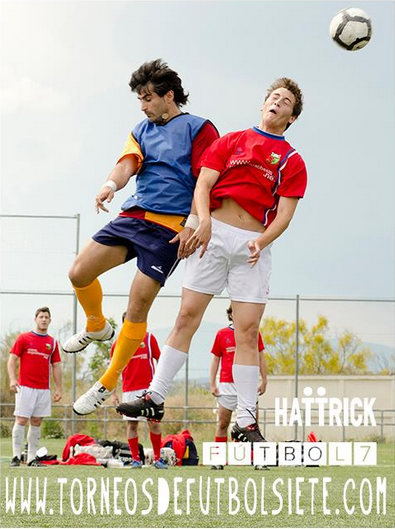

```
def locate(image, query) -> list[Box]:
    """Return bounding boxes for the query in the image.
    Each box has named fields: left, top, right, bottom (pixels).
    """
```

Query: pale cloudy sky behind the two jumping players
left=1, top=0, right=395, bottom=368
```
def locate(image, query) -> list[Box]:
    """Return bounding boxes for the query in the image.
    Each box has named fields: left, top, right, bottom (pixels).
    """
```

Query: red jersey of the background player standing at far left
left=10, top=331, right=61, bottom=389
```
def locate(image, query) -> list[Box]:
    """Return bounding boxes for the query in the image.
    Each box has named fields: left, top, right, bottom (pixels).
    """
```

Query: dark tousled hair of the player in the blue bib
left=129, top=59, right=189, bottom=107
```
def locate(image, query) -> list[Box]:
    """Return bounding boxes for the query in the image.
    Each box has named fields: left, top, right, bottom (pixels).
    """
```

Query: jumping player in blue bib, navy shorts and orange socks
left=63, top=59, right=219, bottom=415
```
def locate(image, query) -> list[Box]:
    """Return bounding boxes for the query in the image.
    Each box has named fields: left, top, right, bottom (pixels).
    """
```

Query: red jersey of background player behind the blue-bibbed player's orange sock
left=111, top=332, right=160, bottom=392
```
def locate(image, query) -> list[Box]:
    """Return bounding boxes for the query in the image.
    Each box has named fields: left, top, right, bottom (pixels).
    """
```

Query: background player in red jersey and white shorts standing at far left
left=7, top=307, right=62, bottom=467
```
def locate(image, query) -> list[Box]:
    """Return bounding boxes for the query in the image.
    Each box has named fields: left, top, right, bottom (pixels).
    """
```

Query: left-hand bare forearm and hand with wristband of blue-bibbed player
left=96, top=155, right=139, bottom=213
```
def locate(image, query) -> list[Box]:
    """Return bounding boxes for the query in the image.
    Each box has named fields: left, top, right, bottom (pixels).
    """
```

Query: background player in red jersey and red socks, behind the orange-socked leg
left=111, top=312, right=167, bottom=469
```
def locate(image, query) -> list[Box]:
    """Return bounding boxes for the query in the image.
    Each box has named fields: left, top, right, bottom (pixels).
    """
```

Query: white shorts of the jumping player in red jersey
left=183, top=218, right=272, bottom=303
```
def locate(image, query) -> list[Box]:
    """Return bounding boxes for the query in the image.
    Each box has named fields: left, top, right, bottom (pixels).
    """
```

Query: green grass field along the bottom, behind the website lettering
left=1, top=439, right=395, bottom=527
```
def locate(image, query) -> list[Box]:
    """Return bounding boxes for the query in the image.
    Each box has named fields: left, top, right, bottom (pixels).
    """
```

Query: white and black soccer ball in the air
left=329, top=7, right=372, bottom=51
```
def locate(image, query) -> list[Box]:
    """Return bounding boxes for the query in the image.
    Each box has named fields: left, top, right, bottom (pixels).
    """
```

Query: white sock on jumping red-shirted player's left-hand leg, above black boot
left=149, top=345, right=188, bottom=404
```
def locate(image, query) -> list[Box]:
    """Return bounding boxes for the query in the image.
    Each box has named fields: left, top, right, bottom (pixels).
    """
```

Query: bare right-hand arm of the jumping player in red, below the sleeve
left=248, top=197, right=299, bottom=265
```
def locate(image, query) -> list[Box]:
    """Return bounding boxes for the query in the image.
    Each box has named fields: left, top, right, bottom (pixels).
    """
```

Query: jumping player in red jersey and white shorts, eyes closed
left=117, top=78, right=307, bottom=442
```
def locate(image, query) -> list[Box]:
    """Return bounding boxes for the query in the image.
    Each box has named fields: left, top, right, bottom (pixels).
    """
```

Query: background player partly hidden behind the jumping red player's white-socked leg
left=210, top=307, right=267, bottom=470
